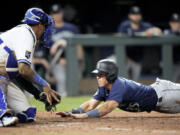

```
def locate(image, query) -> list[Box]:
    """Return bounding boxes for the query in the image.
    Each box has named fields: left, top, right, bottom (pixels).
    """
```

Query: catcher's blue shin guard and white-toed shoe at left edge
left=0, top=79, right=18, bottom=127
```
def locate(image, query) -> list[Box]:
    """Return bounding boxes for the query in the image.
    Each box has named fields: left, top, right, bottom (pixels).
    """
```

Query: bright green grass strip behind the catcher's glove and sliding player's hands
left=29, top=96, right=91, bottom=112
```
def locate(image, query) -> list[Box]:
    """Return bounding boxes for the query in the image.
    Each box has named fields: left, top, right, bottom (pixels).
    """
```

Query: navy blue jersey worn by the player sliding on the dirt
left=93, top=78, right=158, bottom=112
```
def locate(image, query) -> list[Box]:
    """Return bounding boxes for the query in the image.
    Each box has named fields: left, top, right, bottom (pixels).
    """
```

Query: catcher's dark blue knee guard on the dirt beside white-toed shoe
left=16, top=107, right=36, bottom=123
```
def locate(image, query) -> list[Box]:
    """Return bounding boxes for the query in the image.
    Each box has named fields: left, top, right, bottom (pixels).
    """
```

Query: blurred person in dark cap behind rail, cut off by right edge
left=164, top=13, right=180, bottom=81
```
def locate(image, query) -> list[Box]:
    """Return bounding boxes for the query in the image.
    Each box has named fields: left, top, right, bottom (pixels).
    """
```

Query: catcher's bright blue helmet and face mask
left=22, top=8, right=54, bottom=48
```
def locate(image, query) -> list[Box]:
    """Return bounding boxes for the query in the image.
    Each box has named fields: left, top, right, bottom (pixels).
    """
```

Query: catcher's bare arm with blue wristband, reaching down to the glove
left=18, top=62, right=59, bottom=104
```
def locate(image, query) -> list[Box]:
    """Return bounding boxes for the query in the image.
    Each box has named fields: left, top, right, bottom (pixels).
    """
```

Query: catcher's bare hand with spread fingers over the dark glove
left=43, top=86, right=61, bottom=105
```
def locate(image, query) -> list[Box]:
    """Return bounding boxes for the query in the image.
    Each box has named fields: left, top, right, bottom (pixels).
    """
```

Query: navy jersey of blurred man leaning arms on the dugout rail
left=118, top=20, right=153, bottom=36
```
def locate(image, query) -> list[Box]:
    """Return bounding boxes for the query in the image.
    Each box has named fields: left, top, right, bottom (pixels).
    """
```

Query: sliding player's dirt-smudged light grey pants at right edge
left=153, top=79, right=180, bottom=113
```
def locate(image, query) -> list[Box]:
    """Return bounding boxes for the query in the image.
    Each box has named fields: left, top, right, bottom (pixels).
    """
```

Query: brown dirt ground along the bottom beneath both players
left=0, top=111, right=180, bottom=135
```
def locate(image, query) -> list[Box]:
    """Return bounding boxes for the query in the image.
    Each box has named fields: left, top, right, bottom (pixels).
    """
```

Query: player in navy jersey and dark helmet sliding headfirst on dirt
left=57, top=59, right=180, bottom=119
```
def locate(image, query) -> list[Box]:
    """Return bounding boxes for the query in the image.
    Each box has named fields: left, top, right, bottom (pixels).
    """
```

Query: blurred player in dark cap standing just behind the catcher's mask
left=50, top=4, right=84, bottom=97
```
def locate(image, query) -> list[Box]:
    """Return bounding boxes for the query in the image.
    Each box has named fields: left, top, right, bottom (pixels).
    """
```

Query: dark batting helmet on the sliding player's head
left=92, top=59, right=118, bottom=83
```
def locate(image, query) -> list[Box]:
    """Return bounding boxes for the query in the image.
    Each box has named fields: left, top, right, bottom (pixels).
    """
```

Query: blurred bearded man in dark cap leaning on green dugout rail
left=118, top=6, right=161, bottom=81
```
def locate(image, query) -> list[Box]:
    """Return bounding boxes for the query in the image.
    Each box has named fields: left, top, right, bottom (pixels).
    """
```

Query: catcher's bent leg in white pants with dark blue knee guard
left=7, top=83, right=36, bottom=122
